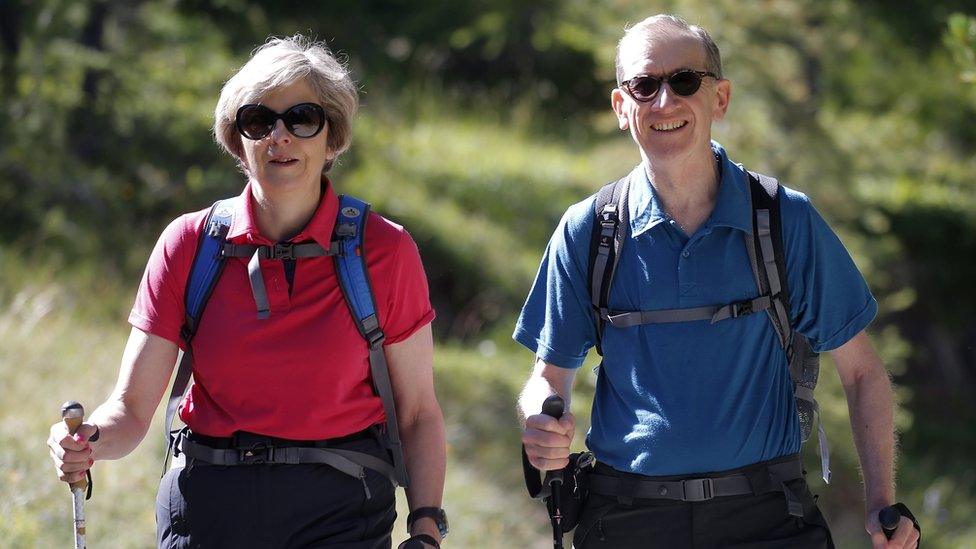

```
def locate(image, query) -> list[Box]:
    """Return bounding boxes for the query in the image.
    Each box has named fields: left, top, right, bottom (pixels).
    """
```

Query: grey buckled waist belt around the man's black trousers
left=589, top=454, right=804, bottom=516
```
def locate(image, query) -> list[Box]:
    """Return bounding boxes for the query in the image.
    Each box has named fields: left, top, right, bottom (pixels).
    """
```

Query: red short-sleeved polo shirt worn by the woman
left=129, top=180, right=434, bottom=440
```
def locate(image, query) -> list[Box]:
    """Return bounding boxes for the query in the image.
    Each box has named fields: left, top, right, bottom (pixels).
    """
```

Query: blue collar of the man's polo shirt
left=628, top=141, right=752, bottom=237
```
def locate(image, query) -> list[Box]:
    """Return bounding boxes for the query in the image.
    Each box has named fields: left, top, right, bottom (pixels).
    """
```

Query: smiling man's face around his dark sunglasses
left=610, top=28, right=731, bottom=165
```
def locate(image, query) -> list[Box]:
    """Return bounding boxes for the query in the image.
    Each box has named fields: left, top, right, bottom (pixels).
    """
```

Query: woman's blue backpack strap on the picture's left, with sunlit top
left=163, top=198, right=235, bottom=474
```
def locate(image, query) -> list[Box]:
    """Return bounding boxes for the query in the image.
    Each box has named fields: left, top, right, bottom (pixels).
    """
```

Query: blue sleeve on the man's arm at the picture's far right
left=782, top=190, right=878, bottom=352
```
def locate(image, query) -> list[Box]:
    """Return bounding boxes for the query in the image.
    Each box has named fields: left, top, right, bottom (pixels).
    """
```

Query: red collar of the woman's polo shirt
left=227, top=175, right=339, bottom=249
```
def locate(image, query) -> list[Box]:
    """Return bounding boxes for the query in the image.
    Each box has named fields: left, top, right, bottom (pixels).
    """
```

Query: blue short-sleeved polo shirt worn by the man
left=514, top=142, right=878, bottom=475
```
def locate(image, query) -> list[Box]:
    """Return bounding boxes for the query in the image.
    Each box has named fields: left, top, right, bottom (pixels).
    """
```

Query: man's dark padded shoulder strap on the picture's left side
left=589, top=175, right=630, bottom=355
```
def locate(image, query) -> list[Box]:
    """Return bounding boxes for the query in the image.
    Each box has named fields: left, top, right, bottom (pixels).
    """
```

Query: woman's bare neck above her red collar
left=251, top=178, right=322, bottom=242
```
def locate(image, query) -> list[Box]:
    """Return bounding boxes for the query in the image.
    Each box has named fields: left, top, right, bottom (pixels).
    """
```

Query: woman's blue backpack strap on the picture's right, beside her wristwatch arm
left=333, top=195, right=409, bottom=487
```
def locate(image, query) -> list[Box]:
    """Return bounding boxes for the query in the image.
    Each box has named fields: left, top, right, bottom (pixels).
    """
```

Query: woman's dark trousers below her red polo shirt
left=156, top=439, right=396, bottom=549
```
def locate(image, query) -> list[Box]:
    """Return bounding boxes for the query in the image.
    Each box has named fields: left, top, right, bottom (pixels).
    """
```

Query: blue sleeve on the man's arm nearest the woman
left=513, top=199, right=596, bottom=368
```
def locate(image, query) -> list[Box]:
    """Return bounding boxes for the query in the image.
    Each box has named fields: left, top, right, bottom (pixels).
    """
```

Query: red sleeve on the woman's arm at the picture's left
left=129, top=215, right=196, bottom=347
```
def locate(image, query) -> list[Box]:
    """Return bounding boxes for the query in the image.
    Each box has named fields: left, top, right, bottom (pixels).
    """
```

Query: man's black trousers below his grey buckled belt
left=573, top=464, right=834, bottom=549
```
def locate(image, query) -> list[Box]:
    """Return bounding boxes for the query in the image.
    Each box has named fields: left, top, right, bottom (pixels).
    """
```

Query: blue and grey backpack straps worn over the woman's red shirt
left=164, top=195, right=409, bottom=487
